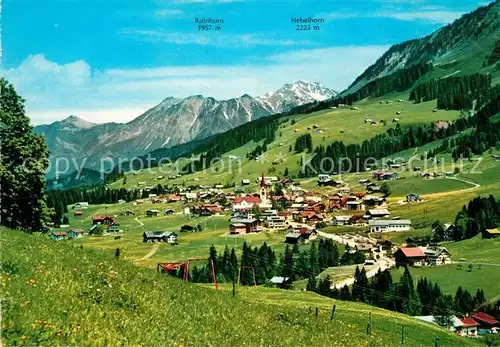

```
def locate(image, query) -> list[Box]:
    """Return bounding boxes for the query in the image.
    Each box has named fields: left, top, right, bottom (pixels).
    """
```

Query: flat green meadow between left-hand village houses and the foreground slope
left=65, top=202, right=302, bottom=267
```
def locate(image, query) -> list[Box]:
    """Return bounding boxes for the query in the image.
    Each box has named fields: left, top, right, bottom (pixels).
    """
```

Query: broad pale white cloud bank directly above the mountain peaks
left=4, top=46, right=388, bottom=124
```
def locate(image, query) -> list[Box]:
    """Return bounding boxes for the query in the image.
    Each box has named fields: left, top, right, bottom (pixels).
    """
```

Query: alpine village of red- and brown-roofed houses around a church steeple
left=44, top=171, right=500, bottom=337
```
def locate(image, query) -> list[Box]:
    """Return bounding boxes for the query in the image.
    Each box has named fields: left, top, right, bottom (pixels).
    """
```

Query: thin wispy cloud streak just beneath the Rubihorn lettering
left=120, top=28, right=314, bottom=47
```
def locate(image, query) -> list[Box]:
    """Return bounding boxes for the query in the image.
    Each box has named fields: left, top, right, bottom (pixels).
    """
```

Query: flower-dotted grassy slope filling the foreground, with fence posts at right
left=0, top=229, right=479, bottom=347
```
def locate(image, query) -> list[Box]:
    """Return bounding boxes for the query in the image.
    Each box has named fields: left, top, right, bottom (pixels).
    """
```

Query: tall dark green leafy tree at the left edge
left=0, top=78, right=48, bottom=232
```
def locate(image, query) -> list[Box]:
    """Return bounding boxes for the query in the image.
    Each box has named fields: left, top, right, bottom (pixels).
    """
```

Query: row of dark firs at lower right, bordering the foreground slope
left=307, top=267, right=487, bottom=327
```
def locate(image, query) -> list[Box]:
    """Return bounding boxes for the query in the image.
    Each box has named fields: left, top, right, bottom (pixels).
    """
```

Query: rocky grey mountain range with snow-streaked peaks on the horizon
left=34, top=81, right=337, bottom=174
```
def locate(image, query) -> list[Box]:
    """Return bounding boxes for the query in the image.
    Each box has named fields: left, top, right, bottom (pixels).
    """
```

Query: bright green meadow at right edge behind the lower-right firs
left=392, top=236, right=500, bottom=299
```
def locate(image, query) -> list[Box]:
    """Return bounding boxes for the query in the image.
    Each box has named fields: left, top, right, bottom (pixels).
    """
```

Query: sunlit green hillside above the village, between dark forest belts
left=111, top=98, right=460, bottom=192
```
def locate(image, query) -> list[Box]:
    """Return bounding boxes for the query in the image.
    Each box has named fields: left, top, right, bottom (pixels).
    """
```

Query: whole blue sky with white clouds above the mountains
left=2, top=0, right=492, bottom=124
